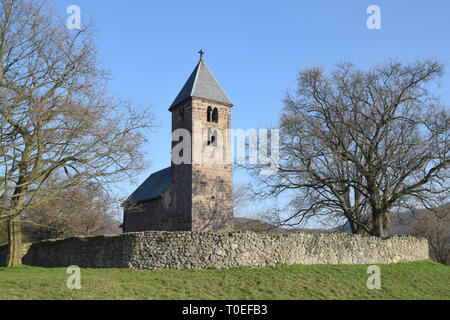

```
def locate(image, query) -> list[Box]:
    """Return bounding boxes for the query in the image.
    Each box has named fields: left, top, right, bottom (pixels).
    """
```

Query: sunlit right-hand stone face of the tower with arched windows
left=192, top=98, right=233, bottom=232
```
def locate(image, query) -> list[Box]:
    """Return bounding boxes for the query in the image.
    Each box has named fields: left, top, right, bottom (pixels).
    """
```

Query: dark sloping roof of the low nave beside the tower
left=124, top=167, right=171, bottom=203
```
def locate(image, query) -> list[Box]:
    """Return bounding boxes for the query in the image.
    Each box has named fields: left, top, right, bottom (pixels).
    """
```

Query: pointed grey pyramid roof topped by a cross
left=169, top=51, right=233, bottom=110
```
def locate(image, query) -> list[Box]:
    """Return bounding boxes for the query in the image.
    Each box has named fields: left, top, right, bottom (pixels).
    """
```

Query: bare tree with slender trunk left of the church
left=0, top=0, right=151, bottom=266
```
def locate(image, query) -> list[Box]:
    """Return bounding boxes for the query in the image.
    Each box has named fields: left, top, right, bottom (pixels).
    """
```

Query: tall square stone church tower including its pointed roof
left=169, top=51, right=233, bottom=232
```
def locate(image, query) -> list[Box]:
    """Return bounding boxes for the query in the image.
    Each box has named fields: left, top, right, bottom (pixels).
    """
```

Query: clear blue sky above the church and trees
left=50, top=0, right=450, bottom=222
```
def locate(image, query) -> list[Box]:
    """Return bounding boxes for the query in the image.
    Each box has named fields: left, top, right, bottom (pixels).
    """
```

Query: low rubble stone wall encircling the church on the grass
left=0, top=231, right=429, bottom=269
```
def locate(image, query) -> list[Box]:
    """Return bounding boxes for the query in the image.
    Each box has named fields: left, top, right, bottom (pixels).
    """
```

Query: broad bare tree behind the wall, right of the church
left=252, top=60, right=449, bottom=237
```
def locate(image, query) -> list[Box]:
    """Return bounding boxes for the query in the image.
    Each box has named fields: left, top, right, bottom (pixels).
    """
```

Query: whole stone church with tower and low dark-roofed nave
left=122, top=51, right=233, bottom=232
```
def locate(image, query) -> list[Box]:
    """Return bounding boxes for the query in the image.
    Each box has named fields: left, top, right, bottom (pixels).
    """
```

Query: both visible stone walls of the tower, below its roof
left=168, top=98, right=233, bottom=232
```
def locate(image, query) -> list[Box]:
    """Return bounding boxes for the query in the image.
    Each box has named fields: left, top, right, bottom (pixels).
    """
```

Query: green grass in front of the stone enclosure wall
left=0, top=261, right=450, bottom=300
